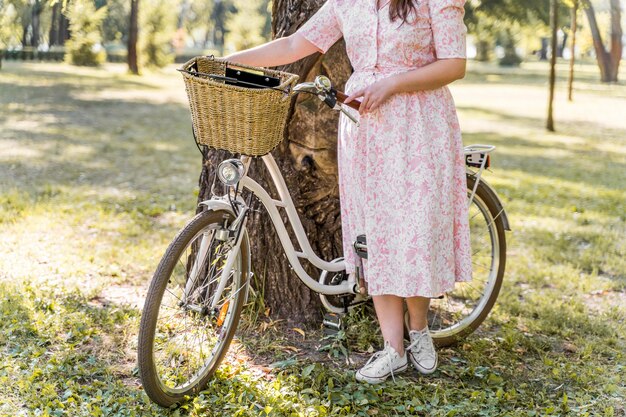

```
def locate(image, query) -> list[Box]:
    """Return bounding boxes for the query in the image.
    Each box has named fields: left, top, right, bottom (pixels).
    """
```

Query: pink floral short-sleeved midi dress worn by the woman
left=298, top=0, right=472, bottom=297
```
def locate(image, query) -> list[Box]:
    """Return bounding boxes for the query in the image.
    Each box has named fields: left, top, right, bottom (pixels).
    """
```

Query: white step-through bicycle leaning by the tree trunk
left=138, top=76, right=510, bottom=407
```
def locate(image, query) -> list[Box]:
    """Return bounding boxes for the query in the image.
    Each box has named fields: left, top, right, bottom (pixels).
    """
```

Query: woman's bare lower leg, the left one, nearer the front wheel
left=372, top=295, right=404, bottom=356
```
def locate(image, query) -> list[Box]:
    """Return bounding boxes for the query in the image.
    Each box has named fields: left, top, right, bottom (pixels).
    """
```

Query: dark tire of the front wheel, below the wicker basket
left=137, top=210, right=250, bottom=407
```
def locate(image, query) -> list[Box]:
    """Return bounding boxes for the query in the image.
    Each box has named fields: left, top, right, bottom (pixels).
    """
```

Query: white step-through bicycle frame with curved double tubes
left=185, top=144, right=495, bottom=308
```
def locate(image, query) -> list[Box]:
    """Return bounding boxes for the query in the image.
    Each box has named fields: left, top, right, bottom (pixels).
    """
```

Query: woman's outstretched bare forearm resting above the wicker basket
left=224, top=34, right=317, bottom=67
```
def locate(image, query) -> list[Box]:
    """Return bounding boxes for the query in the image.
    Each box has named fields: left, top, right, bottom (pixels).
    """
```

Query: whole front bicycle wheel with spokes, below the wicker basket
left=138, top=210, right=250, bottom=407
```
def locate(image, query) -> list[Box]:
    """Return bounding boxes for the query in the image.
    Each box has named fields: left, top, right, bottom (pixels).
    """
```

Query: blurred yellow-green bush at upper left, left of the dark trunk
left=65, top=0, right=107, bottom=66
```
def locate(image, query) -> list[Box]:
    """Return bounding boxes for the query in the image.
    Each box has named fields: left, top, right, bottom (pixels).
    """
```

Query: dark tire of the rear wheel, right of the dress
left=414, top=175, right=506, bottom=347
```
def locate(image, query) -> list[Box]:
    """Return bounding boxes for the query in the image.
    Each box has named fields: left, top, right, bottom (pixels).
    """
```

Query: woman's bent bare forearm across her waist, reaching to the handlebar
left=392, top=58, right=466, bottom=93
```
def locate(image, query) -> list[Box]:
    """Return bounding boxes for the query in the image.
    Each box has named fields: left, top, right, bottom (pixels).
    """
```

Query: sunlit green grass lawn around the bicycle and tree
left=0, top=62, right=626, bottom=416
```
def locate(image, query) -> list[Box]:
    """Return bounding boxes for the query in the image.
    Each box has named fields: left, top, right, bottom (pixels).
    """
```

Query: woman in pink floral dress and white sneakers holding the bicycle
left=225, top=0, right=471, bottom=383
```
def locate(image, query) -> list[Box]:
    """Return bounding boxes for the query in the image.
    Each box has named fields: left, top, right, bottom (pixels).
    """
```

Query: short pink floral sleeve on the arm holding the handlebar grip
left=429, top=0, right=467, bottom=59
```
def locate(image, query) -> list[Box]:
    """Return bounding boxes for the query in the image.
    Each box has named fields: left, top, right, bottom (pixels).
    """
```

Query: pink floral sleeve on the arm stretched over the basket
left=296, top=0, right=343, bottom=54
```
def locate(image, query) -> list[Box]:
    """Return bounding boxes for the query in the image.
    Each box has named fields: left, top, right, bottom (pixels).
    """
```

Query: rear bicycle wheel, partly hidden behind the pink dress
left=424, top=175, right=506, bottom=346
